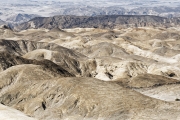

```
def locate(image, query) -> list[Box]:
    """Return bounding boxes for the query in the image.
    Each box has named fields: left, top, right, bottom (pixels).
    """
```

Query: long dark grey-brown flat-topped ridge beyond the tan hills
left=14, top=15, right=180, bottom=30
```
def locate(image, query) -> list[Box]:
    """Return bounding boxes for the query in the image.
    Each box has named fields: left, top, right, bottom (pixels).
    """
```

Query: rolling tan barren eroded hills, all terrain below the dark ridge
left=0, top=26, right=180, bottom=120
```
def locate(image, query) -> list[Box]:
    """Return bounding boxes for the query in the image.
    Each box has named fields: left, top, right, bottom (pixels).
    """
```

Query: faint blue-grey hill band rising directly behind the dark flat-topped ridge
left=49, top=6, right=180, bottom=18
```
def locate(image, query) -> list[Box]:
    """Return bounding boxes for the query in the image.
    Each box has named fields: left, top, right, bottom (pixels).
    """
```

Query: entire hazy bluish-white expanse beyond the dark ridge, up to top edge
left=0, top=0, right=180, bottom=24
